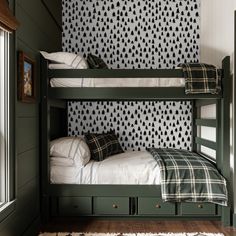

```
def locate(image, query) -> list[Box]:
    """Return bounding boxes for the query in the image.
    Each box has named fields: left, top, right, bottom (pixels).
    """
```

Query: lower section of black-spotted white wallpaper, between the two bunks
left=68, top=101, right=192, bottom=150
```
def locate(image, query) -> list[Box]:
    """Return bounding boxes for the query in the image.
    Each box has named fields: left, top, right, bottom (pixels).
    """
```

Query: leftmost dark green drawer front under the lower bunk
left=58, top=197, right=92, bottom=216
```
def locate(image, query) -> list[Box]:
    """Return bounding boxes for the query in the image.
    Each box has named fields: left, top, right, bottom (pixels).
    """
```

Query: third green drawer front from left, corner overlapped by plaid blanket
left=138, top=197, right=176, bottom=215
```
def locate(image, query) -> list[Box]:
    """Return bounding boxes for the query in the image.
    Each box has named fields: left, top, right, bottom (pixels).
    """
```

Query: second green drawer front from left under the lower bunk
left=93, top=197, right=129, bottom=215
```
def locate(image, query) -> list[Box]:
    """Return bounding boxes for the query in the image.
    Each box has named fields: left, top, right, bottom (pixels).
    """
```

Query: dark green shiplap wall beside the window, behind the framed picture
left=0, top=0, right=61, bottom=236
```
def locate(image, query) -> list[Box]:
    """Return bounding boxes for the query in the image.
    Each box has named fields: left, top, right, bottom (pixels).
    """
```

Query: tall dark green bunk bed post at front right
left=218, top=56, right=231, bottom=226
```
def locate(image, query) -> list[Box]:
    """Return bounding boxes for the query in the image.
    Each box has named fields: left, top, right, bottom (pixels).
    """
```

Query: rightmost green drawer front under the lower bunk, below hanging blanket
left=181, top=202, right=216, bottom=215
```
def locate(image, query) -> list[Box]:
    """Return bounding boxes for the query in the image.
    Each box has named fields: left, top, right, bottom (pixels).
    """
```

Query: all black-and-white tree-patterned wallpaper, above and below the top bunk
left=62, top=0, right=197, bottom=150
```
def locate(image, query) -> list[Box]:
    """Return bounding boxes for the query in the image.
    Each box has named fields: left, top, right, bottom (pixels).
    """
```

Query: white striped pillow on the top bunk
left=40, top=51, right=89, bottom=69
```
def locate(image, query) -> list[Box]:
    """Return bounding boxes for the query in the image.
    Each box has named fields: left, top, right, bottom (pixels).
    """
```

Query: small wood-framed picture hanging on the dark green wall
left=17, top=51, right=36, bottom=102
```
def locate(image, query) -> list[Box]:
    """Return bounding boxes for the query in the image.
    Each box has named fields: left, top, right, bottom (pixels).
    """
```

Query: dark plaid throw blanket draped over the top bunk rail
left=180, top=63, right=221, bottom=94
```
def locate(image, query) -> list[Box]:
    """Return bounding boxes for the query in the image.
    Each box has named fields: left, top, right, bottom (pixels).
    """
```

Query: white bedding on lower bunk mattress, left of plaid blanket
left=51, top=151, right=160, bottom=185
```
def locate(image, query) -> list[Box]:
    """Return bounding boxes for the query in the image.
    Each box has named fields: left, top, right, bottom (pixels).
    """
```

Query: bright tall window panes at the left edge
left=0, top=29, right=10, bottom=210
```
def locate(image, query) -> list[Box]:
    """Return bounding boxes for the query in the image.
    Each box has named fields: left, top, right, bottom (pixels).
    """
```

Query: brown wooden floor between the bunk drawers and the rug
left=42, top=219, right=236, bottom=236
